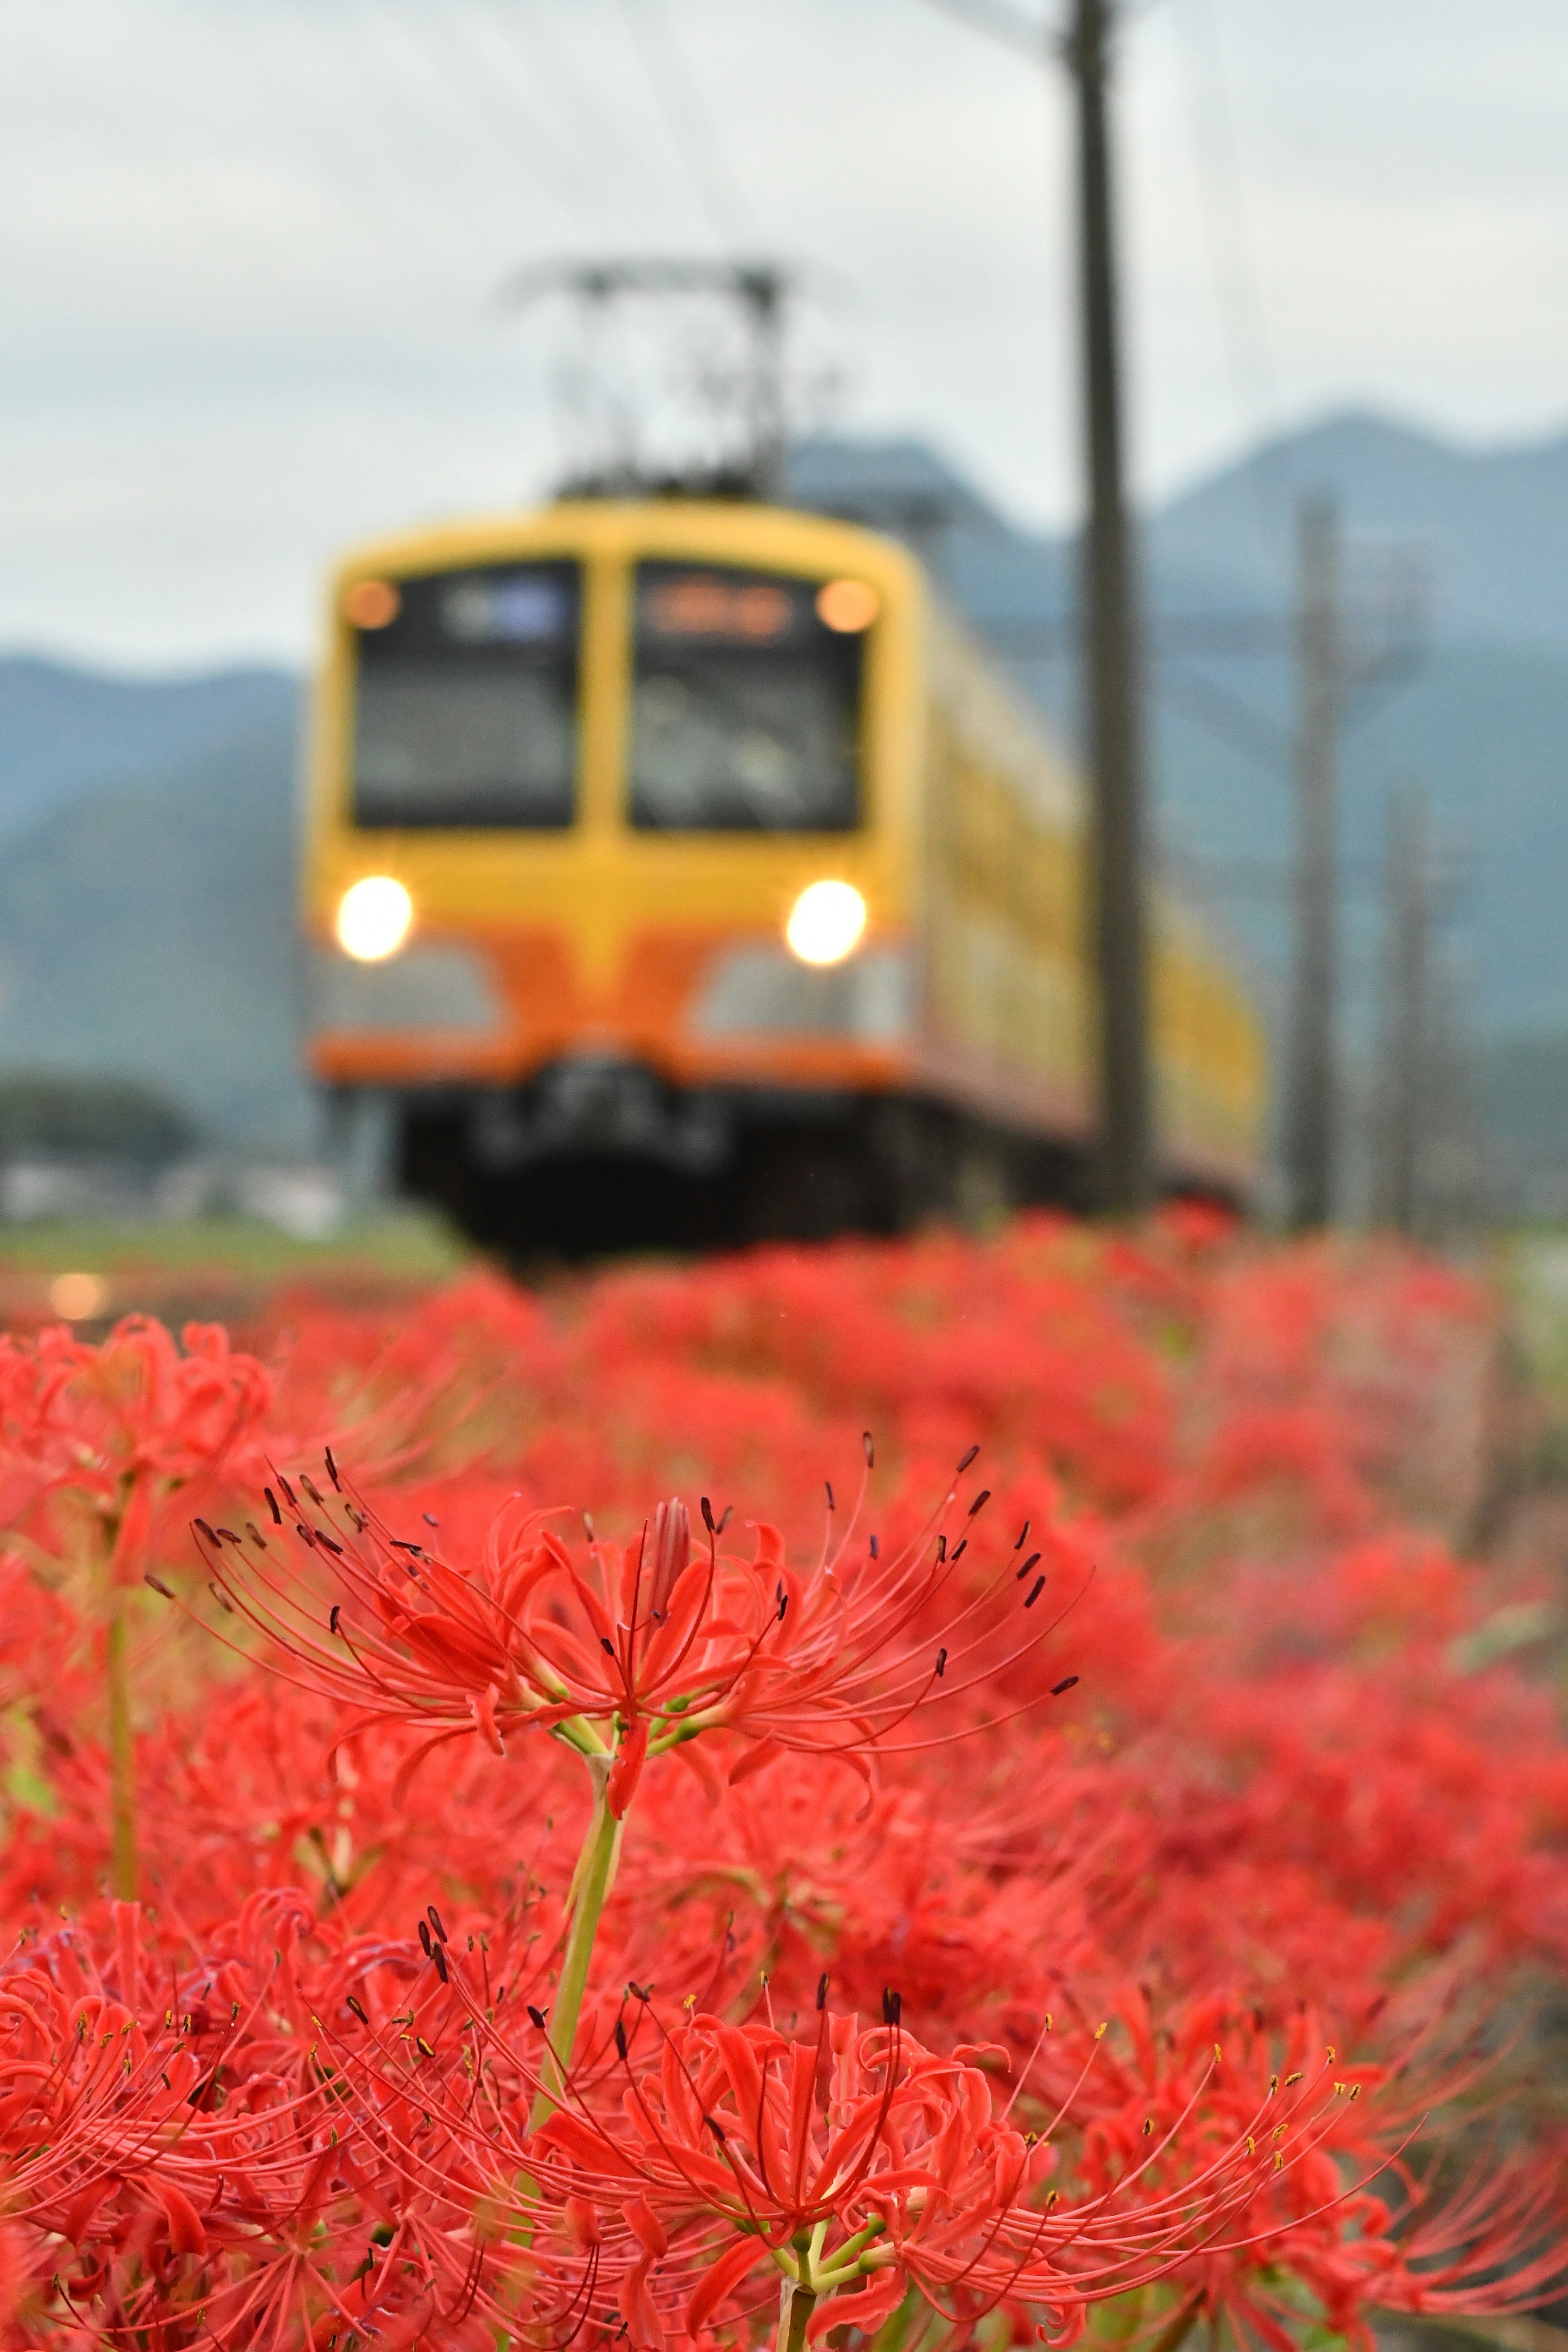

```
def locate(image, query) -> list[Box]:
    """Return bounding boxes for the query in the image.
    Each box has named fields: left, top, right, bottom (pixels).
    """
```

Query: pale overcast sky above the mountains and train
left=0, top=0, right=1568, bottom=668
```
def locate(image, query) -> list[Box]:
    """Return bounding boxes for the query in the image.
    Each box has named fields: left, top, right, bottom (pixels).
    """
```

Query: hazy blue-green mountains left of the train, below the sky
left=0, top=659, right=313, bottom=1157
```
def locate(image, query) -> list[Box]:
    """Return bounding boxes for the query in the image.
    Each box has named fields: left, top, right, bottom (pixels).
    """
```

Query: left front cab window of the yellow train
left=343, top=562, right=581, bottom=830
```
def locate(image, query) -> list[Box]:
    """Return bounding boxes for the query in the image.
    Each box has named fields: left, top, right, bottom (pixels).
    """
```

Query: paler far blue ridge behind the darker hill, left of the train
left=0, top=654, right=298, bottom=837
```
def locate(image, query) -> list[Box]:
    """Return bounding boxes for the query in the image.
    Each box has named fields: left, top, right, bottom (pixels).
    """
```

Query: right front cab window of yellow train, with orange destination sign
left=630, top=562, right=877, bottom=833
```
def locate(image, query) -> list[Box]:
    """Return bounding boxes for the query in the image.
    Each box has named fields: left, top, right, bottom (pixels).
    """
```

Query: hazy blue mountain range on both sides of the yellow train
left=0, top=414, right=1568, bottom=1195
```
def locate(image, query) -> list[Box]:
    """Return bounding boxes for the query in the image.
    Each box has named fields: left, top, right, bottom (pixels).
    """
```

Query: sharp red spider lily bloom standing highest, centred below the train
left=198, top=1444, right=1089, bottom=1818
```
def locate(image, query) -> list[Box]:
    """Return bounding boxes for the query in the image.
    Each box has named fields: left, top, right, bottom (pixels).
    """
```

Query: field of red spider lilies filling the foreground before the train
left=0, top=1211, right=1568, bottom=2352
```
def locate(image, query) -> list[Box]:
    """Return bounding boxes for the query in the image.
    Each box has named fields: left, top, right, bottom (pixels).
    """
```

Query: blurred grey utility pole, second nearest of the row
left=1286, top=496, right=1345, bottom=1230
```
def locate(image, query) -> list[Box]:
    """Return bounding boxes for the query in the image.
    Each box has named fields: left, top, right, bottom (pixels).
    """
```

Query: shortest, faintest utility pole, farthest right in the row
left=1375, top=790, right=1434, bottom=1232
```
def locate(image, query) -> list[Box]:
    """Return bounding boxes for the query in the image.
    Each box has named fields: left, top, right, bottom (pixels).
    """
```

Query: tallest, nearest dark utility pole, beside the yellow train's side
left=1062, top=0, right=1154, bottom=1216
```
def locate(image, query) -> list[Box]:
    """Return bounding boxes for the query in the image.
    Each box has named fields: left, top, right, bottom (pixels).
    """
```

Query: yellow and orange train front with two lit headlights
left=303, top=501, right=922, bottom=1254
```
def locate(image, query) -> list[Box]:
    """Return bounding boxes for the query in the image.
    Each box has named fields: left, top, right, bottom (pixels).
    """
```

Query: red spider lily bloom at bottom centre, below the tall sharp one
left=527, top=1980, right=1297, bottom=2347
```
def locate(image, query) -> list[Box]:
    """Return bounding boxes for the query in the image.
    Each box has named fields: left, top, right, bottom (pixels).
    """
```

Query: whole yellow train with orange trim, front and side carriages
left=303, top=499, right=1265, bottom=1254
